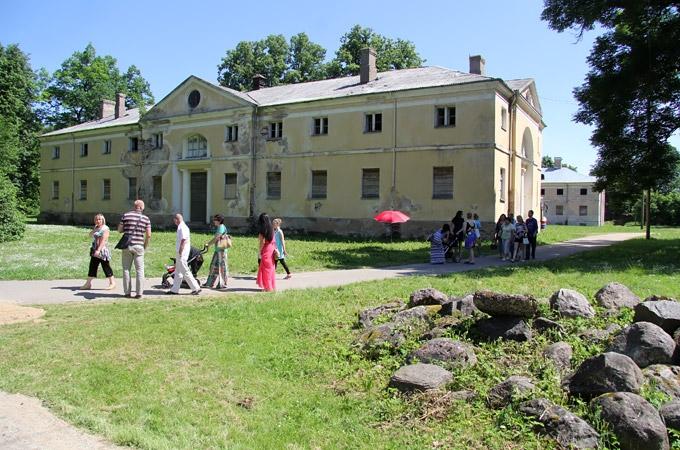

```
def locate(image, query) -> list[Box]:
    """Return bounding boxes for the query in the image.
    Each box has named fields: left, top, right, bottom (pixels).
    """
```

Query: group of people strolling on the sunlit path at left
left=81, top=200, right=291, bottom=299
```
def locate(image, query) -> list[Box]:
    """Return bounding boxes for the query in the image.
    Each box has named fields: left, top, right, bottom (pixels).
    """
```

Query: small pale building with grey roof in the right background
left=541, top=158, right=604, bottom=226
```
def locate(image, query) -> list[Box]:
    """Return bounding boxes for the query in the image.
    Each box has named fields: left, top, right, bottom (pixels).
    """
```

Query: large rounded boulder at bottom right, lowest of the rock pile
left=591, top=392, right=670, bottom=450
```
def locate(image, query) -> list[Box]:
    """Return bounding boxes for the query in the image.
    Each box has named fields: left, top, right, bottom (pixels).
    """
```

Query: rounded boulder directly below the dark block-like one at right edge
left=608, top=322, right=675, bottom=367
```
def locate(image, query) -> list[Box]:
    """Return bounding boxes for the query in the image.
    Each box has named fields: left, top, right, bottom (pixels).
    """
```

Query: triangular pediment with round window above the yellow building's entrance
left=142, top=75, right=257, bottom=122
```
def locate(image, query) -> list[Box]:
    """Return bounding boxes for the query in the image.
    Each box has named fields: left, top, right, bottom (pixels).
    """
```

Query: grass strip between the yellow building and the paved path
left=0, top=224, right=637, bottom=280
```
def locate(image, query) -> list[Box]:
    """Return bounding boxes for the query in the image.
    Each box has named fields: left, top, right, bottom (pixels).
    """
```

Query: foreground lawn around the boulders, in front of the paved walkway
left=0, top=229, right=680, bottom=449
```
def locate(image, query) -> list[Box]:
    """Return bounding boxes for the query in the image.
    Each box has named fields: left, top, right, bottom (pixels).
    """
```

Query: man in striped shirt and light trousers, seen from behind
left=118, top=200, right=151, bottom=298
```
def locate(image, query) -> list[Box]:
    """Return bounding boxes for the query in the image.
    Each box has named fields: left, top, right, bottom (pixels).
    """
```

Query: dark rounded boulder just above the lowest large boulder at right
left=562, top=352, right=643, bottom=397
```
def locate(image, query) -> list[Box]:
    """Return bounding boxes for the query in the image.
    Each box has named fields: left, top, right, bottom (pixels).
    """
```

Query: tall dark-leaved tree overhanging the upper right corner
left=542, top=0, right=680, bottom=239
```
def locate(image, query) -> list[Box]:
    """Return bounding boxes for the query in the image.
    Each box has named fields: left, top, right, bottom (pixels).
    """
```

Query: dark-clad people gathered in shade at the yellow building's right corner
left=428, top=210, right=539, bottom=264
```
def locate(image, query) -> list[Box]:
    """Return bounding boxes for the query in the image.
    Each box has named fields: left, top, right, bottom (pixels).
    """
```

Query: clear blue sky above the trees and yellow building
left=0, top=0, right=680, bottom=173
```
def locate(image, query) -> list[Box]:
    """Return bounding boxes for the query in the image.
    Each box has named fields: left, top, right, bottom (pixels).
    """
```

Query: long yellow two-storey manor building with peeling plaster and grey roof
left=40, top=49, right=545, bottom=236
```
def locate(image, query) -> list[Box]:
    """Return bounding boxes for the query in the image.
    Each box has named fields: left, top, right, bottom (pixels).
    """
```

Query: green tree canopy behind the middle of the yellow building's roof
left=217, top=25, right=424, bottom=91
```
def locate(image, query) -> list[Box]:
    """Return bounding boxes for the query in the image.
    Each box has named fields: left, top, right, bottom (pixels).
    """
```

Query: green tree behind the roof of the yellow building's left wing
left=44, top=44, right=154, bottom=128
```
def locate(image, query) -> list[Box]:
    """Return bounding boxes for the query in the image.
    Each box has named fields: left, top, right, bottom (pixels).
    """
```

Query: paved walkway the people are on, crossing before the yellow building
left=0, top=233, right=642, bottom=305
